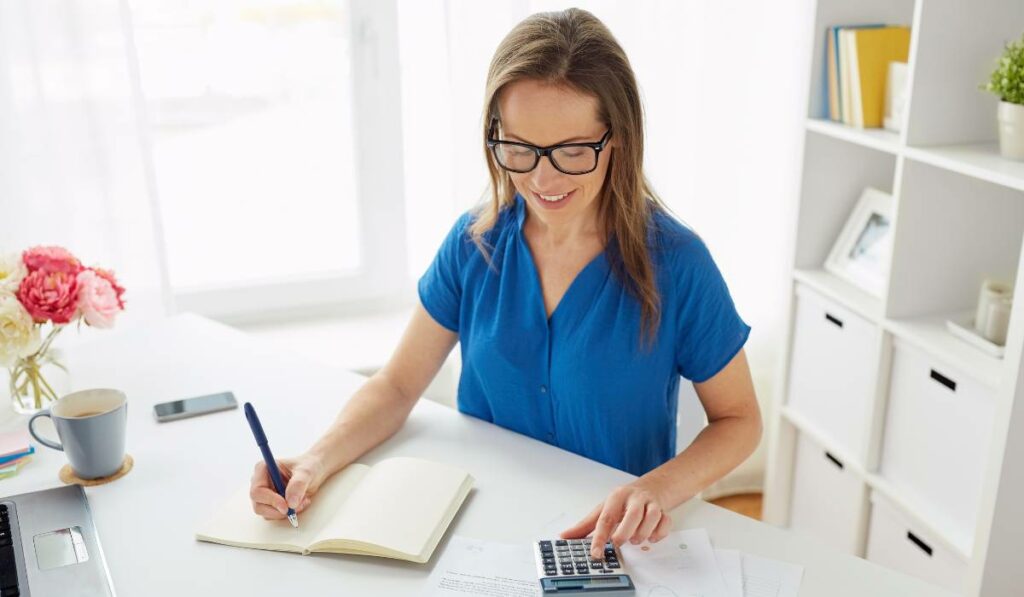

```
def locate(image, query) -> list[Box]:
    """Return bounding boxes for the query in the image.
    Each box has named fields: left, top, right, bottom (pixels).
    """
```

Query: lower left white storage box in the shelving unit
left=790, top=434, right=865, bottom=554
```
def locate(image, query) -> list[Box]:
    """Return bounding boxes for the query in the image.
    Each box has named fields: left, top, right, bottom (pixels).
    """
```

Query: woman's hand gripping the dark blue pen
left=249, top=454, right=325, bottom=520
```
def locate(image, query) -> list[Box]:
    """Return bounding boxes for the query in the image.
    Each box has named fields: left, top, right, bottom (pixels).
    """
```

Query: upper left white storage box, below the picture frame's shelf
left=787, top=285, right=879, bottom=456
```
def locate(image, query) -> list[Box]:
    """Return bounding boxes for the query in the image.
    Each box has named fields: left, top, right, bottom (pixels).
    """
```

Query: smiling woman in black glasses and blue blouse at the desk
left=251, top=9, right=761, bottom=557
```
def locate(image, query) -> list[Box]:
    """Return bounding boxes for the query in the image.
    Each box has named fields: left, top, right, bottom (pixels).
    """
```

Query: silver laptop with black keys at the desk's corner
left=0, top=485, right=114, bottom=597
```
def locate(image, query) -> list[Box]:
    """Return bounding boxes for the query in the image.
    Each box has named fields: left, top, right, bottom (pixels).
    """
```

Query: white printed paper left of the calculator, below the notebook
left=427, top=535, right=541, bottom=597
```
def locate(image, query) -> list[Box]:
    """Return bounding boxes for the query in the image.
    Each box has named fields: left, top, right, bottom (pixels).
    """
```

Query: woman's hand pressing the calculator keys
left=561, top=480, right=672, bottom=558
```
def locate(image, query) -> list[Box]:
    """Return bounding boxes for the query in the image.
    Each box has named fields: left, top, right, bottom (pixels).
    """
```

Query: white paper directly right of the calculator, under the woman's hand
left=620, top=528, right=730, bottom=597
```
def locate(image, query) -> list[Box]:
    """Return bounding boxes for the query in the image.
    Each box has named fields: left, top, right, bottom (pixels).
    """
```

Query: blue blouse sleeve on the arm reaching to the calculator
left=675, top=237, right=751, bottom=383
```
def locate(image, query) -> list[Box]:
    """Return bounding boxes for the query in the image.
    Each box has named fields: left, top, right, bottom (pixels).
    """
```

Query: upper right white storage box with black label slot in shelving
left=879, top=339, right=995, bottom=551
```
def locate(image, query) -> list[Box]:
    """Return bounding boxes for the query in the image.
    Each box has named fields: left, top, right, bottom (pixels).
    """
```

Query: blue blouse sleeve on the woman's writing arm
left=418, top=212, right=473, bottom=333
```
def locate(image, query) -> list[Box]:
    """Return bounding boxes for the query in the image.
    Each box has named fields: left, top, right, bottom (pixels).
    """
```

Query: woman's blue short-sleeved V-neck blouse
left=419, top=195, right=751, bottom=475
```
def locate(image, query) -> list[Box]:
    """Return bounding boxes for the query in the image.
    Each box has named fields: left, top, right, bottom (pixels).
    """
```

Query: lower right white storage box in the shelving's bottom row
left=864, top=493, right=967, bottom=592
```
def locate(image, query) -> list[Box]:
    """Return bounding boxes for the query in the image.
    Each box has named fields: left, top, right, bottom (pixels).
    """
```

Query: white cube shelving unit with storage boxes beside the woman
left=764, top=0, right=1024, bottom=597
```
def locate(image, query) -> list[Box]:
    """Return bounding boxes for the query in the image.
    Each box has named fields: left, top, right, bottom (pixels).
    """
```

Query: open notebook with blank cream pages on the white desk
left=196, top=458, right=473, bottom=563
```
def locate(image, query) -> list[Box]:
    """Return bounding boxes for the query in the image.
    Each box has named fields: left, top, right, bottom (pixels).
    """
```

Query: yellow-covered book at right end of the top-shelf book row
left=844, top=27, right=910, bottom=128
